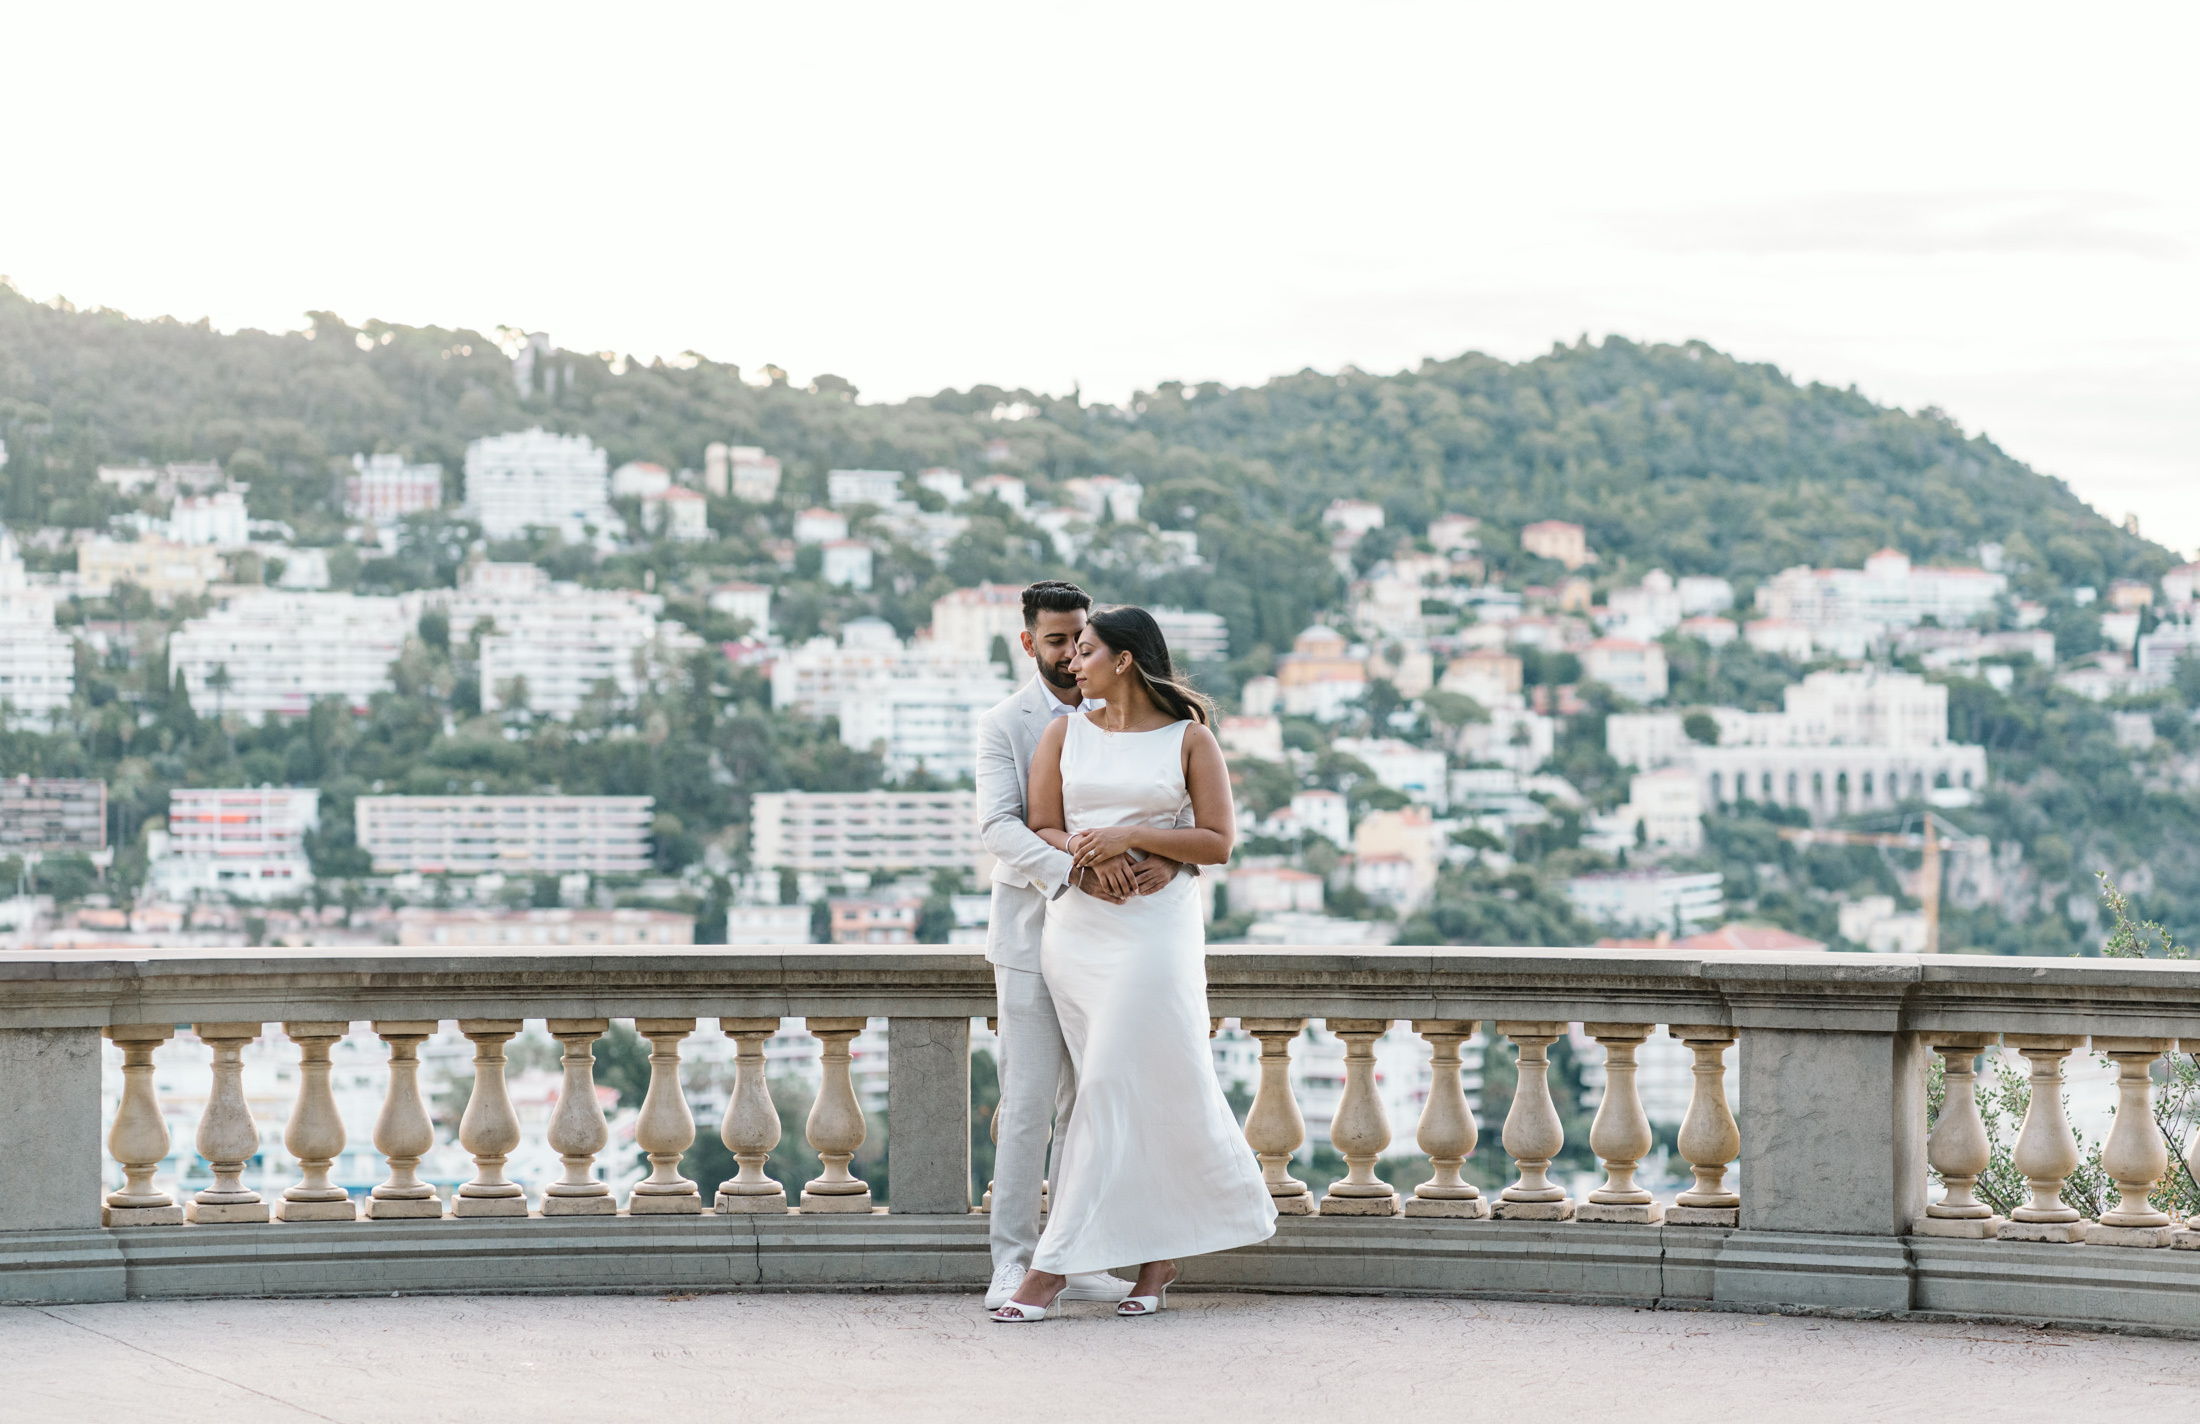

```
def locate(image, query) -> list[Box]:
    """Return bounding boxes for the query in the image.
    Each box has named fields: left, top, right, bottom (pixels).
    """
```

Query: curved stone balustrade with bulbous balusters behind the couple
left=0, top=946, right=2200, bottom=1329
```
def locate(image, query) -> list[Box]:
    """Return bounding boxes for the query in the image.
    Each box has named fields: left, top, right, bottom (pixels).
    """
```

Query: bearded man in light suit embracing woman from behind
left=977, top=579, right=1179, bottom=1310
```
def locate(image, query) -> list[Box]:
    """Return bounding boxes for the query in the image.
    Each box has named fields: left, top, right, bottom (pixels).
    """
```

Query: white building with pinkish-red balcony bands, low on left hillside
left=147, top=786, right=321, bottom=900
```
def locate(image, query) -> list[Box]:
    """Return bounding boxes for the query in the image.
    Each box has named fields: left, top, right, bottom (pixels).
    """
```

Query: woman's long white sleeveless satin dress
left=1032, top=713, right=1276, bottom=1274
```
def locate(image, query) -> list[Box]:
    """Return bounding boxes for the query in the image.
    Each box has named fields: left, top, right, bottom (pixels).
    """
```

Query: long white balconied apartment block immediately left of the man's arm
left=748, top=790, right=986, bottom=874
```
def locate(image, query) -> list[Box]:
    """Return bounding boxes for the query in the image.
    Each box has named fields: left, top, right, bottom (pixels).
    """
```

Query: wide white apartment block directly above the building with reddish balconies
left=167, top=588, right=418, bottom=722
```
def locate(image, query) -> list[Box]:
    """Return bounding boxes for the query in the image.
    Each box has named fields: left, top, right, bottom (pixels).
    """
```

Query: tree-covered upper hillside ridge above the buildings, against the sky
left=0, top=288, right=2171, bottom=616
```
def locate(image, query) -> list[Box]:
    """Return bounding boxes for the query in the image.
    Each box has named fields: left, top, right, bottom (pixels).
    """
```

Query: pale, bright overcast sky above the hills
left=0, top=0, right=2200, bottom=557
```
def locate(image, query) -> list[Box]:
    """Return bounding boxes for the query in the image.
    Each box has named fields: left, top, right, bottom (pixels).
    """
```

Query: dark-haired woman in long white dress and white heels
left=992, top=607, right=1276, bottom=1323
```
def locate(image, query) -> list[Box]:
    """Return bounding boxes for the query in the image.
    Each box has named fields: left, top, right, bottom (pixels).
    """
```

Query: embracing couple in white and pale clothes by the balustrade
left=977, top=581, right=1276, bottom=1323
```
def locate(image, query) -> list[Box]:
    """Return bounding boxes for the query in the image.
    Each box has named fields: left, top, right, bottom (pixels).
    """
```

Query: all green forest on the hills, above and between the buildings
left=0, top=286, right=2200, bottom=951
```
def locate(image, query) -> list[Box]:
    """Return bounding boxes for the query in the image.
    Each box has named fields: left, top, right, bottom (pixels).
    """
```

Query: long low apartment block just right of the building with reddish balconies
left=352, top=797, right=656, bottom=876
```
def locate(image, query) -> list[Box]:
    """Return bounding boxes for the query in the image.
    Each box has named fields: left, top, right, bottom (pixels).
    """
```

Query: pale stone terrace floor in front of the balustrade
left=0, top=1292, right=2200, bottom=1424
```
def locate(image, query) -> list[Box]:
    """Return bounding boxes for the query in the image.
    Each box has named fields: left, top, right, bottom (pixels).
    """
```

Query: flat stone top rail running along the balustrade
left=0, top=944, right=2200, bottom=1037
